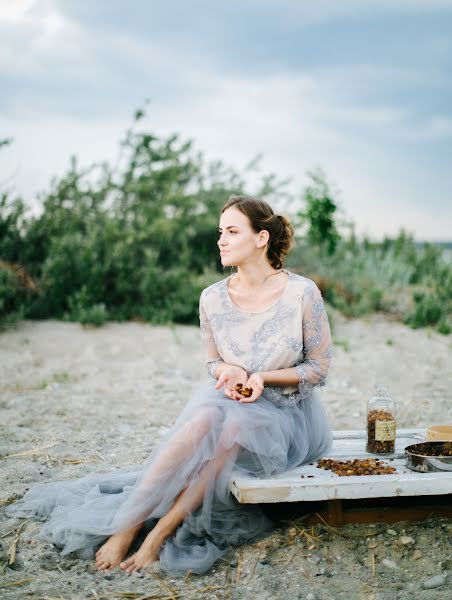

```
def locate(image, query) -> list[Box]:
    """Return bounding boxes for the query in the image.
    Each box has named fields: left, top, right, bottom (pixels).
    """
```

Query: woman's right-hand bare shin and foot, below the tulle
left=120, top=430, right=240, bottom=573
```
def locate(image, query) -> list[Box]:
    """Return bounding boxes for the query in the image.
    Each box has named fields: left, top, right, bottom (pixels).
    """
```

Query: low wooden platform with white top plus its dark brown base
left=230, top=429, right=452, bottom=525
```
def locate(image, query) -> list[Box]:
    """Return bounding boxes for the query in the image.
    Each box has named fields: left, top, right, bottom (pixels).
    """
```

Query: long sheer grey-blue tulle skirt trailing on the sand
left=7, top=380, right=332, bottom=575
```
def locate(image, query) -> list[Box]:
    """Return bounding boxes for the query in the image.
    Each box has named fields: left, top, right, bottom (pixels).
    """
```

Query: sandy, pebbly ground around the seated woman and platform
left=0, top=314, right=452, bottom=600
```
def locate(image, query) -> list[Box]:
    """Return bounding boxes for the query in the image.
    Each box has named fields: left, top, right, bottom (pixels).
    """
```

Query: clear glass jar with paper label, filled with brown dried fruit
left=366, top=384, right=397, bottom=454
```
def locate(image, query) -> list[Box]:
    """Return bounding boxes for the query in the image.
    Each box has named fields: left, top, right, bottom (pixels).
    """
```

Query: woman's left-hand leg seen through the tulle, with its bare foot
left=95, top=407, right=219, bottom=571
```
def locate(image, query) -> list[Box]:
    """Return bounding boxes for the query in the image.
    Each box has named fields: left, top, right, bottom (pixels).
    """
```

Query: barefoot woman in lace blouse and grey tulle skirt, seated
left=8, top=196, right=331, bottom=575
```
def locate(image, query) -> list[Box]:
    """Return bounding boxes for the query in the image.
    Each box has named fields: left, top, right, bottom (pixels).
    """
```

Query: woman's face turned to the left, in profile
left=217, top=206, right=268, bottom=267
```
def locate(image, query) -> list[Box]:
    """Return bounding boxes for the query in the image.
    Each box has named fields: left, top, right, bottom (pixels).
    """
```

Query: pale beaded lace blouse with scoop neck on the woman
left=199, top=269, right=332, bottom=405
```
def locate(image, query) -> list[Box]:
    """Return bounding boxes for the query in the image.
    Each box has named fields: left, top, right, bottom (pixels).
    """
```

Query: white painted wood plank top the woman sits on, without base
left=230, top=429, right=452, bottom=503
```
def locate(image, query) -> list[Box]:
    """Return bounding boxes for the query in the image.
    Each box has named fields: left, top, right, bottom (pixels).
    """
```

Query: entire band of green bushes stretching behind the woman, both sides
left=0, top=111, right=452, bottom=333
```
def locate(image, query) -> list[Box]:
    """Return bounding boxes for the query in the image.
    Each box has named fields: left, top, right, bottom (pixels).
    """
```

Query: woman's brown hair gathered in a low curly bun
left=221, top=196, right=294, bottom=269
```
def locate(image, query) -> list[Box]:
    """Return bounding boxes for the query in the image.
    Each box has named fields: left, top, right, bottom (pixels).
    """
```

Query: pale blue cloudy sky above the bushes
left=0, top=0, right=452, bottom=241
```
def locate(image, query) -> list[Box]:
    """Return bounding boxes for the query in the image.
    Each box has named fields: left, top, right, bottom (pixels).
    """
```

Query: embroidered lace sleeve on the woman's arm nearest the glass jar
left=295, top=282, right=332, bottom=398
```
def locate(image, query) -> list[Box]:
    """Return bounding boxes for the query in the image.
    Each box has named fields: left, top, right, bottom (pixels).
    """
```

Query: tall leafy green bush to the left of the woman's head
left=0, top=113, right=290, bottom=324
